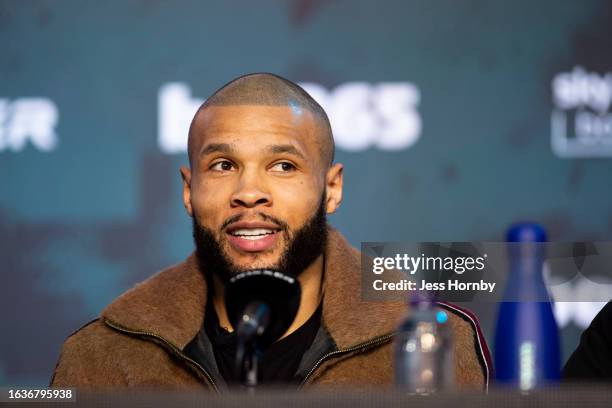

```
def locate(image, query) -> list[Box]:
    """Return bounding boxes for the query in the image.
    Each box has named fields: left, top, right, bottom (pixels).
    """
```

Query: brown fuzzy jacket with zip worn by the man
left=51, top=229, right=490, bottom=390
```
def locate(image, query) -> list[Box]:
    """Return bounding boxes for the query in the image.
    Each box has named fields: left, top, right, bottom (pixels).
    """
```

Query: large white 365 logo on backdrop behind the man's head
left=158, top=82, right=422, bottom=154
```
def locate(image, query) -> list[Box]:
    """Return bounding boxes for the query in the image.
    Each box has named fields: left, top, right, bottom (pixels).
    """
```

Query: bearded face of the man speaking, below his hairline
left=182, top=105, right=341, bottom=279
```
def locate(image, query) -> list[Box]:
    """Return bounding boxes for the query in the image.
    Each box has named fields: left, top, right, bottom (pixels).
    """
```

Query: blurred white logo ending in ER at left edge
left=0, top=98, right=59, bottom=152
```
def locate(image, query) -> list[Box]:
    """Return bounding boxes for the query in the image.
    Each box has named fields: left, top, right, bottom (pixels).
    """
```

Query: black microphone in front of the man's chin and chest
left=225, top=270, right=302, bottom=387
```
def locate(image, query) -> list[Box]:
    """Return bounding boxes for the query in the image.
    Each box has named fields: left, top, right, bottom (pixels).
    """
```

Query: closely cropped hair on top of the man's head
left=188, top=73, right=334, bottom=168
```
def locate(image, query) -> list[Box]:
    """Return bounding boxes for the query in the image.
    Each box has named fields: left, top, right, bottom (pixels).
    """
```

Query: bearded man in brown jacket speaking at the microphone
left=52, top=74, right=490, bottom=391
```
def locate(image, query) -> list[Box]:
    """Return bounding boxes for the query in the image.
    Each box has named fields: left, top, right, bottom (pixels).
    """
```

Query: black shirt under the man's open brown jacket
left=194, top=302, right=321, bottom=384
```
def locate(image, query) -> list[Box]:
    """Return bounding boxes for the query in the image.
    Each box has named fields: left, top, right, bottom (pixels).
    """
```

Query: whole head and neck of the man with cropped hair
left=180, top=74, right=344, bottom=306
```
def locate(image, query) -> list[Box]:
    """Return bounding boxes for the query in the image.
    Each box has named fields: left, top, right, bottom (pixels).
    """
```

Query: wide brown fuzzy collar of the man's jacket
left=102, top=227, right=405, bottom=349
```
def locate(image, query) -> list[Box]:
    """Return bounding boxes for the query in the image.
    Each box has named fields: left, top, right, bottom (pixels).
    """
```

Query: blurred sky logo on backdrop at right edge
left=551, top=66, right=612, bottom=158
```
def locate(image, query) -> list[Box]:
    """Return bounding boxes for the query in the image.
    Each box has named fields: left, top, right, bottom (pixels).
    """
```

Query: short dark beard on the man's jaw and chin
left=192, top=195, right=327, bottom=283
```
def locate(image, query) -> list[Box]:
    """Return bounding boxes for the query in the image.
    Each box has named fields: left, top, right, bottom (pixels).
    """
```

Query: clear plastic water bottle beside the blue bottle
left=395, top=302, right=455, bottom=394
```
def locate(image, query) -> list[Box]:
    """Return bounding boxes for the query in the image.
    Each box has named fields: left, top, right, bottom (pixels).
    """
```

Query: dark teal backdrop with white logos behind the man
left=0, top=0, right=612, bottom=385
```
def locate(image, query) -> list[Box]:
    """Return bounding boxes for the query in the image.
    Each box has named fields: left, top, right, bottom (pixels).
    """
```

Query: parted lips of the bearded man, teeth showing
left=226, top=221, right=280, bottom=252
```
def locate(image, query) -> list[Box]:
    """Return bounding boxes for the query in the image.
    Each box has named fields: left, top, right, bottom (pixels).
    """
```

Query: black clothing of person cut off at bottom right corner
left=563, top=303, right=612, bottom=381
